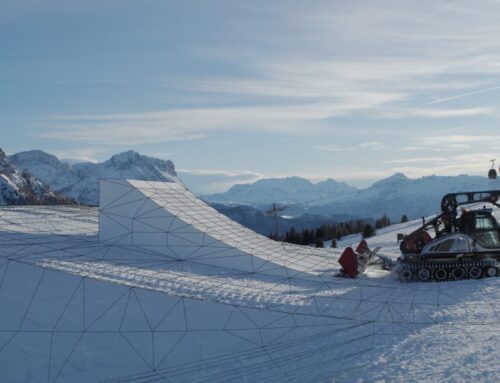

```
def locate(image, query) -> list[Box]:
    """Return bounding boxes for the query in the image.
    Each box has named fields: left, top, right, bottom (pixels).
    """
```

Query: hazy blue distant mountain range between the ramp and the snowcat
left=204, top=173, right=500, bottom=220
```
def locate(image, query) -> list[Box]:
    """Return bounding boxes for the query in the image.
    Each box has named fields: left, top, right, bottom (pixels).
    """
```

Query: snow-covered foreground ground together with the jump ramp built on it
left=0, top=180, right=500, bottom=383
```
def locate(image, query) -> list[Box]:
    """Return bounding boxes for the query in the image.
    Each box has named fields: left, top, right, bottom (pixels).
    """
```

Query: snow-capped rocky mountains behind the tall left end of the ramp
left=9, top=150, right=177, bottom=206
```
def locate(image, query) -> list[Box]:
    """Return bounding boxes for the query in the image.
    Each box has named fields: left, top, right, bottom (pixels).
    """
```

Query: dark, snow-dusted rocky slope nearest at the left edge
left=0, top=149, right=75, bottom=205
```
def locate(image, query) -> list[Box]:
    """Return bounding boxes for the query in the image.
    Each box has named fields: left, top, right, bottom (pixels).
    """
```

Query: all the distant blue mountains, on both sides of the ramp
left=4, top=150, right=500, bottom=225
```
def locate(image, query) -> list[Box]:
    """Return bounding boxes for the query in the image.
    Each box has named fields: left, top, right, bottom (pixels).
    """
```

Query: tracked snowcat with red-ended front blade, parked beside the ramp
left=339, top=190, right=500, bottom=282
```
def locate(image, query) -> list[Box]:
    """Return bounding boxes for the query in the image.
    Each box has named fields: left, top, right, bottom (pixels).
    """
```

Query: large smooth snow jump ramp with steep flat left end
left=99, top=180, right=335, bottom=276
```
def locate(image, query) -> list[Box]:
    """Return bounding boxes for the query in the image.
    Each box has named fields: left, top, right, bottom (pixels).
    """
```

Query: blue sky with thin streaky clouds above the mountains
left=0, top=0, right=500, bottom=192
